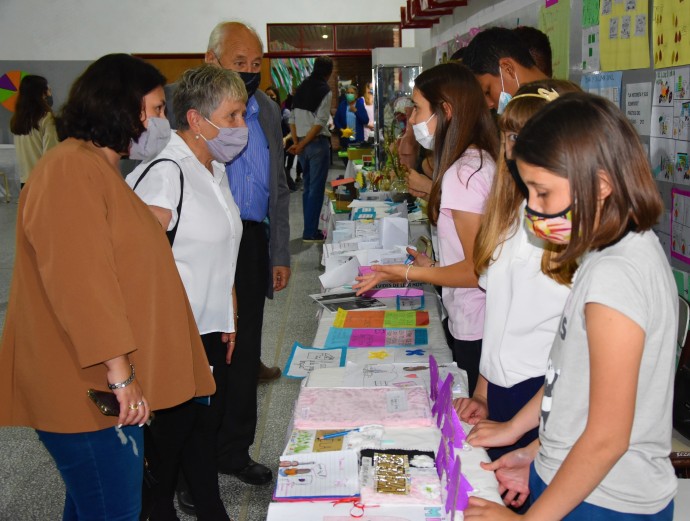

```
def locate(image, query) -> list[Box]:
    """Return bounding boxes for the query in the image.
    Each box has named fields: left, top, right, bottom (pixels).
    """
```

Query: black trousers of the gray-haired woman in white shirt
left=150, top=333, right=228, bottom=521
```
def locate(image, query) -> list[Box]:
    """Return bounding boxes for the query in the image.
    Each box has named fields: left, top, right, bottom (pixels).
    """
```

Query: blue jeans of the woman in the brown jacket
left=36, top=425, right=144, bottom=521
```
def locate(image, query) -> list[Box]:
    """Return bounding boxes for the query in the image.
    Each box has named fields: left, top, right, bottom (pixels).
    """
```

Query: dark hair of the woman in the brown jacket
left=55, top=54, right=165, bottom=153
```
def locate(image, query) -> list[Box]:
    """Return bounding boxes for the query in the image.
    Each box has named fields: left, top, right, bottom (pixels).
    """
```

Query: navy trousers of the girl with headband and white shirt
left=486, top=376, right=544, bottom=461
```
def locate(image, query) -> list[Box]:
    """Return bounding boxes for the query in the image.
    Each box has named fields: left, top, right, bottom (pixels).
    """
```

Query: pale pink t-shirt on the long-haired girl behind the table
left=437, top=148, right=496, bottom=340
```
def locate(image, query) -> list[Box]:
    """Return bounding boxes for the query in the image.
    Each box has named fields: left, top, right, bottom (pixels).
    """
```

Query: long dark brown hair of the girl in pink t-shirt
left=415, top=62, right=498, bottom=224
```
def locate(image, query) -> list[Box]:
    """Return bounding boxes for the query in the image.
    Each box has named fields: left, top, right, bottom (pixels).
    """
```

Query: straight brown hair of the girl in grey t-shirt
left=514, top=93, right=663, bottom=276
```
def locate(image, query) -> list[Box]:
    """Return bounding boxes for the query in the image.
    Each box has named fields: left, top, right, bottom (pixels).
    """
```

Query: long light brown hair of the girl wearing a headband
left=474, top=80, right=580, bottom=284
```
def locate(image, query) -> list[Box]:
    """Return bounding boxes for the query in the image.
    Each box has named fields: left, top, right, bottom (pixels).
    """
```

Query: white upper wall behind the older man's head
left=0, top=0, right=414, bottom=60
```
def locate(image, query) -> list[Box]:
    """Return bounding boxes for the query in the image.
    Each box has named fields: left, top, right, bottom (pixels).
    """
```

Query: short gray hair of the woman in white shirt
left=173, top=63, right=247, bottom=130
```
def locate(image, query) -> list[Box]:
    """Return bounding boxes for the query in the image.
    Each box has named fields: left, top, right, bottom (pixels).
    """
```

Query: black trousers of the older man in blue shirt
left=218, top=221, right=270, bottom=470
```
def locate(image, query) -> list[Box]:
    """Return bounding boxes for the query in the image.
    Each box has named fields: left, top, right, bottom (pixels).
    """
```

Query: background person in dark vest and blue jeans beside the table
left=289, top=56, right=333, bottom=243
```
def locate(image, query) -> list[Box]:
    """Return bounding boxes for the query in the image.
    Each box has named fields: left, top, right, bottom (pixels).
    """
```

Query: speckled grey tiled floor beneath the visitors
left=0, top=170, right=342, bottom=521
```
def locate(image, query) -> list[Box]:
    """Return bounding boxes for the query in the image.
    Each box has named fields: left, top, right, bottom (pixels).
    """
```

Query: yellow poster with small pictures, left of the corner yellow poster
left=599, top=0, right=649, bottom=71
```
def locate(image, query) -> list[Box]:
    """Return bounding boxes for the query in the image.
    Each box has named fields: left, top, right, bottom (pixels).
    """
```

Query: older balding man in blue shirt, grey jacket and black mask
left=205, top=22, right=290, bottom=485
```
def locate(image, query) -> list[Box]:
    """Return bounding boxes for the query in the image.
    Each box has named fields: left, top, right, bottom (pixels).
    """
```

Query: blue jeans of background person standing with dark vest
left=299, top=136, right=331, bottom=239
